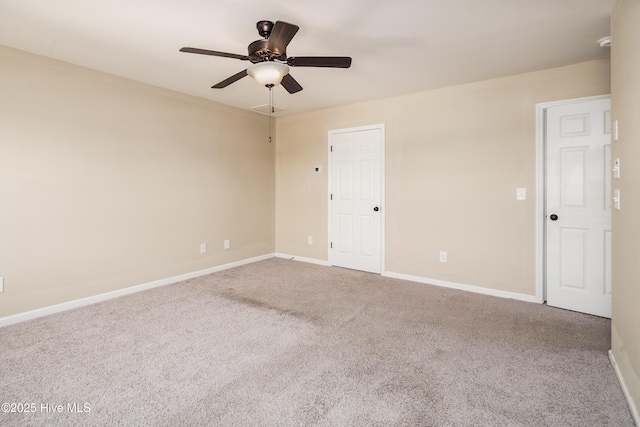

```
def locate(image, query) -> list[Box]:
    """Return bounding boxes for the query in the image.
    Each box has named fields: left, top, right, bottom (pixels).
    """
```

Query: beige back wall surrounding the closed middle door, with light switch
left=276, top=61, right=610, bottom=295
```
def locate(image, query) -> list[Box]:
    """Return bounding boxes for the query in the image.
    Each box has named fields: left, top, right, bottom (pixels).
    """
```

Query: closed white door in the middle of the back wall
left=329, top=126, right=384, bottom=273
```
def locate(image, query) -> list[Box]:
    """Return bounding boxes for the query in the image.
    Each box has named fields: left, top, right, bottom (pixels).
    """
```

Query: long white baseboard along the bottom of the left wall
left=0, top=254, right=274, bottom=327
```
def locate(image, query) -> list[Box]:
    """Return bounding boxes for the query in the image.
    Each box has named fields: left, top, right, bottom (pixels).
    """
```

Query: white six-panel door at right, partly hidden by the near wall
left=546, top=98, right=612, bottom=318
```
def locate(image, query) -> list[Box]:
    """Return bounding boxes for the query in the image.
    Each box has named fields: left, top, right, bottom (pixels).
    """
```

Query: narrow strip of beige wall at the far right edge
left=611, top=0, right=640, bottom=421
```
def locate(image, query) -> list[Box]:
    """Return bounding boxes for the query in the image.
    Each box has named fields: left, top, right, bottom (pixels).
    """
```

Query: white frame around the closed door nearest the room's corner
left=327, top=123, right=387, bottom=275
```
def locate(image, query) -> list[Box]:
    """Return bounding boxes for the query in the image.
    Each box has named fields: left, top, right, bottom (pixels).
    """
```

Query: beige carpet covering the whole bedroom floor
left=0, top=259, right=633, bottom=427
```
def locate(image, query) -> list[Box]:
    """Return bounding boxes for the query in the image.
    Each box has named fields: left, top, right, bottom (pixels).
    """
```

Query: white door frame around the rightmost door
left=535, top=94, right=611, bottom=304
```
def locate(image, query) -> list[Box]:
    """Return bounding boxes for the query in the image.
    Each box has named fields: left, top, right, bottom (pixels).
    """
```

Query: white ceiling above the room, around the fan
left=0, top=0, right=615, bottom=116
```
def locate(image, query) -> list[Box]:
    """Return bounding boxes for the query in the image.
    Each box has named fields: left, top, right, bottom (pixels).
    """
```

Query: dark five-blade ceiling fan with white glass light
left=180, top=21, right=351, bottom=93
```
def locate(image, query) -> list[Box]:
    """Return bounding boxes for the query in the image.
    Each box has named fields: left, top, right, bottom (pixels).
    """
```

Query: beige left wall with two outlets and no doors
left=0, top=47, right=275, bottom=317
